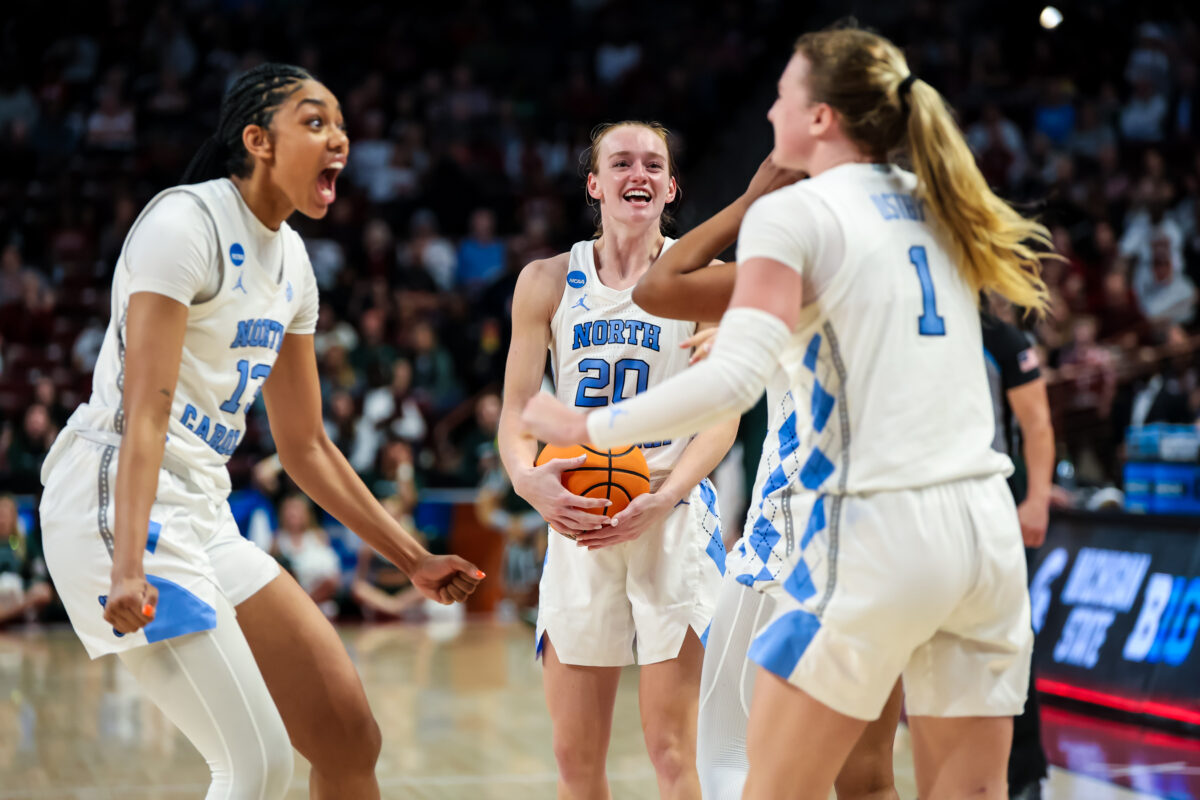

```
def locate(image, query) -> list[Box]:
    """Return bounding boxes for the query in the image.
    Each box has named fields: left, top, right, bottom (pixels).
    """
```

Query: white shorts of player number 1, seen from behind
left=731, top=475, right=1033, bottom=720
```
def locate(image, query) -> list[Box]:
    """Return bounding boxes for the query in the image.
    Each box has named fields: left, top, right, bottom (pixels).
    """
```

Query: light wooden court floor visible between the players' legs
left=0, top=609, right=1153, bottom=800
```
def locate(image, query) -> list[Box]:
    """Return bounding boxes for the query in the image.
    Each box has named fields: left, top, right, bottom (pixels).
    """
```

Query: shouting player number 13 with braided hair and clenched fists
left=41, top=64, right=482, bottom=799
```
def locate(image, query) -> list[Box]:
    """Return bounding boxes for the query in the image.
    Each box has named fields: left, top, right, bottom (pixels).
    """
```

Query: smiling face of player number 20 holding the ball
left=588, top=125, right=678, bottom=225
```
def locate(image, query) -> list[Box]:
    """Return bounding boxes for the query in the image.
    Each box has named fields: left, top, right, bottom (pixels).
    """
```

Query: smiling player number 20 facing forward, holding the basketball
left=499, top=122, right=737, bottom=799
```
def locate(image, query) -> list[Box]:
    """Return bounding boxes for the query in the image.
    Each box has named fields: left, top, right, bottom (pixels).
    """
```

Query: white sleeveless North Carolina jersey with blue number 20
left=550, top=239, right=696, bottom=486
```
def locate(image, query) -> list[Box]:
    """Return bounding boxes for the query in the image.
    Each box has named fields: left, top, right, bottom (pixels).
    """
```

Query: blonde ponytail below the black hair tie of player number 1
left=905, top=80, right=1054, bottom=314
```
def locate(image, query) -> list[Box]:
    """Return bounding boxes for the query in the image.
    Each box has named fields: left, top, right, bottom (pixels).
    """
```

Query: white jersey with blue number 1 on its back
left=738, top=164, right=1012, bottom=583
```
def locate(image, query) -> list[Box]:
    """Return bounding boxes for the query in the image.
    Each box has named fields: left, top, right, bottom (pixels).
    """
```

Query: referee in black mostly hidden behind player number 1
left=983, top=313, right=1055, bottom=800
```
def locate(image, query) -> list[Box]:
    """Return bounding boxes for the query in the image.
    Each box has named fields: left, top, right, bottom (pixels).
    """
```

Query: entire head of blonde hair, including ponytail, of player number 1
left=796, top=28, right=1054, bottom=313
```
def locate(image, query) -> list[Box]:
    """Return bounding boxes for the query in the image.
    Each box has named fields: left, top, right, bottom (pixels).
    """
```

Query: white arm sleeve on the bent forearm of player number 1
left=588, top=308, right=791, bottom=449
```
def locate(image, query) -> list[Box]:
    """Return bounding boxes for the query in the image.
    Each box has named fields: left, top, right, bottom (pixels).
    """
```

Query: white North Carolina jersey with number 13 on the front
left=54, top=179, right=316, bottom=493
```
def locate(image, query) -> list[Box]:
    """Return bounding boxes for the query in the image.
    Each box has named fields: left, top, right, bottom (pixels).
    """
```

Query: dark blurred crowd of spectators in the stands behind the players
left=0, top=0, right=1200, bottom=615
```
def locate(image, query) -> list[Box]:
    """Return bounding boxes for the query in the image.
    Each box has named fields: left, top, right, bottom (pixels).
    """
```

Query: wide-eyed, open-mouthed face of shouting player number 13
left=242, top=80, right=350, bottom=219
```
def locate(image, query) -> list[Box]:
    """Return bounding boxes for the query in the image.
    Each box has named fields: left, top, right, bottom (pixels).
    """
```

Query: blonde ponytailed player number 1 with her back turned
left=522, top=29, right=1049, bottom=800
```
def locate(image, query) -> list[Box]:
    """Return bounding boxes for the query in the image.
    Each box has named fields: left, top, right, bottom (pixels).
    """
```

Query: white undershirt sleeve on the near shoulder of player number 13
left=125, top=192, right=221, bottom=306
